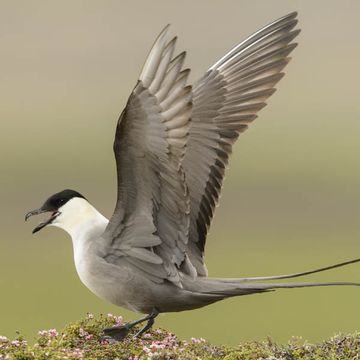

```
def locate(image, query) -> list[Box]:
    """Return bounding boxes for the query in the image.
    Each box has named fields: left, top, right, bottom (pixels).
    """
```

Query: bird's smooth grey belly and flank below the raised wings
left=76, top=257, right=220, bottom=314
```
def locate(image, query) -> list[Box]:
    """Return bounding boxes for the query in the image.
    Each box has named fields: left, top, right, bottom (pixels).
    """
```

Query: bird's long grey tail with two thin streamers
left=198, top=259, right=360, bottom=300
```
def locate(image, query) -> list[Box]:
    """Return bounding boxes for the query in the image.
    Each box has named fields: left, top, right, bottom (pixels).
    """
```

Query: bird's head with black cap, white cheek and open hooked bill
left=25, top=189, right=90, bottom=234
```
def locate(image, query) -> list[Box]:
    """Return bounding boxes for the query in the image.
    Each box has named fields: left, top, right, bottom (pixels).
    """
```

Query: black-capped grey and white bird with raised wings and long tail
left=25, top=12, right=360, bottom=341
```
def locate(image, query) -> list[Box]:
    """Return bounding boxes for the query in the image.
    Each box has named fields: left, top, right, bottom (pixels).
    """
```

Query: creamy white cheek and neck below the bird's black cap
left=50, top=197, right=109, bottom=243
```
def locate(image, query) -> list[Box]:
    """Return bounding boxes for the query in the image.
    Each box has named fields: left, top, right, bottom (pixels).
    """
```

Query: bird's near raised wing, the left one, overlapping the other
left=104, top=27, right=196, bottom=286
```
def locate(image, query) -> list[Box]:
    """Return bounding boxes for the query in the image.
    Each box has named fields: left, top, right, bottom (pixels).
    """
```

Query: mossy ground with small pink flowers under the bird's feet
left=0, top=314, right=360, bottom=360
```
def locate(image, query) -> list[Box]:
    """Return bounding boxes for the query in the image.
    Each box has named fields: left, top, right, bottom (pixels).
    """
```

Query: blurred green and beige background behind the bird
left=0, top=0, right=360, bottom=344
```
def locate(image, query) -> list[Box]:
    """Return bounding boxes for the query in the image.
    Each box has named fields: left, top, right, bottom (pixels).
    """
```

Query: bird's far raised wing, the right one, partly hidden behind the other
left=183, top=13, right=299, bottom=276
